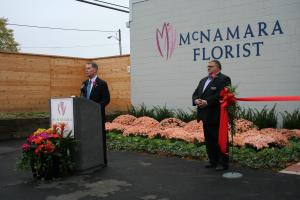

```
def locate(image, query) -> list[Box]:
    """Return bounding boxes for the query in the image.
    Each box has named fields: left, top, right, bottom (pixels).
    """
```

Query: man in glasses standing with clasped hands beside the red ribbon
left=192, top=60, right=231, bottom=171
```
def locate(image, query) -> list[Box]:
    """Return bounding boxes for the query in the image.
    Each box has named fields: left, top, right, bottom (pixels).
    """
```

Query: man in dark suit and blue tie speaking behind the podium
left=80, top=62, right=110, bottom=165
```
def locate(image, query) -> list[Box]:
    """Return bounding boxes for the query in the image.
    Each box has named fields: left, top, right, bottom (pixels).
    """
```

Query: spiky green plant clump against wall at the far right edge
left=281, top=109, right=300, bottom=129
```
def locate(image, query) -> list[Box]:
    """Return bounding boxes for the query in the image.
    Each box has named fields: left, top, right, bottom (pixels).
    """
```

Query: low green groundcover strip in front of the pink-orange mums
left=107, top=132, right=300, bottom=169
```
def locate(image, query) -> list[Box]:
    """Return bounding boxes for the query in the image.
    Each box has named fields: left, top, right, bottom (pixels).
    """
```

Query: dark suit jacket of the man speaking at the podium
left=80, top=77, right=110, bottom=122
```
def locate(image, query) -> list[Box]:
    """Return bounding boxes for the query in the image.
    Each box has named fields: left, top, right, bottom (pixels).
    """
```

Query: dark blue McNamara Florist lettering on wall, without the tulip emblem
left=179, top=20, right=284, bottom=61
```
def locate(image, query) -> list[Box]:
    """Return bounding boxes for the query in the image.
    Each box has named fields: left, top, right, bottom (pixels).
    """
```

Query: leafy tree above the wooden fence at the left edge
left=0, top=18, right=19, bottom=52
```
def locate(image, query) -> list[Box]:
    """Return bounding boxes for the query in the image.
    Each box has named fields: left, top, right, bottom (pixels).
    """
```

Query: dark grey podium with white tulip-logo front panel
left=49, top=97, right=104, bottom=172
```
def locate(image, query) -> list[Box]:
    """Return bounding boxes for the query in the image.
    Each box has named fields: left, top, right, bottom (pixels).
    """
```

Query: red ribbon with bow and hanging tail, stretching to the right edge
left=219, top=87, right=300, bottom=154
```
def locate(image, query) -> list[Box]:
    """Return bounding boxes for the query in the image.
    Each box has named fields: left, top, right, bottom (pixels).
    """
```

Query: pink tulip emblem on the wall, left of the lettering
left=156, top=22, right=176, bottom=60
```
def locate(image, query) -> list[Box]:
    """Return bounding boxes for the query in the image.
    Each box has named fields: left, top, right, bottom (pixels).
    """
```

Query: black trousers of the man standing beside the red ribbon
left=203, top=123, right=229, bottom=166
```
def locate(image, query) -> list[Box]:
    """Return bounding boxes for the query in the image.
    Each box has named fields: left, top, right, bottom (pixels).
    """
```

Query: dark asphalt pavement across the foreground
left=0, top=140, right=300, bottom=200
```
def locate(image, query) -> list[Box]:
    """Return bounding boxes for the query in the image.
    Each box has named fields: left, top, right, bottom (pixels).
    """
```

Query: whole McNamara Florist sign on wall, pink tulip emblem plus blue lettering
left=155, top=20, right=284, bottom=61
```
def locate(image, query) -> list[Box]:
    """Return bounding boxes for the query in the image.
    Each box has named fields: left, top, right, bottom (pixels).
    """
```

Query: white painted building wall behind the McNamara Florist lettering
left=130, top=0, right=300, bottom=115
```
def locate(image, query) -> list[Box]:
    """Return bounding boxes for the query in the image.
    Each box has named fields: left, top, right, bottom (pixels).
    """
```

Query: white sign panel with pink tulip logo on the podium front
left=51, top=98, right=74, bottom=137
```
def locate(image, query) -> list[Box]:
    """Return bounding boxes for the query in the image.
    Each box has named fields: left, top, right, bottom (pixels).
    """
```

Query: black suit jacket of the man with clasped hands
left=192, top=72, right=231, bottom=124
